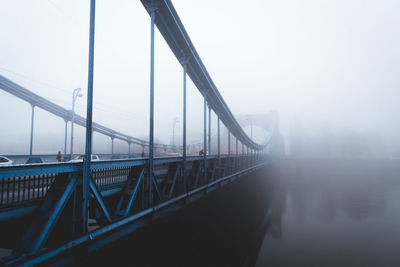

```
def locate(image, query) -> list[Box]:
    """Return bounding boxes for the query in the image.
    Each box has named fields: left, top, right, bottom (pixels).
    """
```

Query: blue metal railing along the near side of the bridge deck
left=0, top=155, right=257, bottom=221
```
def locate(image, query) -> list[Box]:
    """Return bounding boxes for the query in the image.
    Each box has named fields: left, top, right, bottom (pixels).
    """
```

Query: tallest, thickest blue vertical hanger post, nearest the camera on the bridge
left=82, top=0, right=96, bottom=233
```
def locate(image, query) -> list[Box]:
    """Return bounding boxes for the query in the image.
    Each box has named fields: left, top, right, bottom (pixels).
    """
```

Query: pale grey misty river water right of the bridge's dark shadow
left=256, top=160, right=400, bottom=266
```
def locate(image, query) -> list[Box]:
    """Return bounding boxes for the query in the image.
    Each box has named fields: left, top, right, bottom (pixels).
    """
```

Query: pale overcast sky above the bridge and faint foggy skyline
left=0, top=0, right=400, bottom=154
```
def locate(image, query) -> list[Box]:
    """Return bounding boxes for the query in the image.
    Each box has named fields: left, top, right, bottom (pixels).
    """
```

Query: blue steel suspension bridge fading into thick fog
left=0, top=0, right=282, bottom=266
